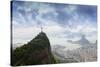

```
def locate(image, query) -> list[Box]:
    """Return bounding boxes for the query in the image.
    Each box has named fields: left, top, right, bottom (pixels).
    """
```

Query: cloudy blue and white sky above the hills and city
left=11, top=1, right=97, bottom=49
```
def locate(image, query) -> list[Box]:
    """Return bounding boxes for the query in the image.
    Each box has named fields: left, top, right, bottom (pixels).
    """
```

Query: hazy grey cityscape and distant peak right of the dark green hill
left=52, top=35, right=97, bottom=63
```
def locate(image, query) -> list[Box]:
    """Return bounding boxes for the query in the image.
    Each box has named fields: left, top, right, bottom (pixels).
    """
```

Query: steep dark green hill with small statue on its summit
left=11, top=32, right=56, bottom=66
